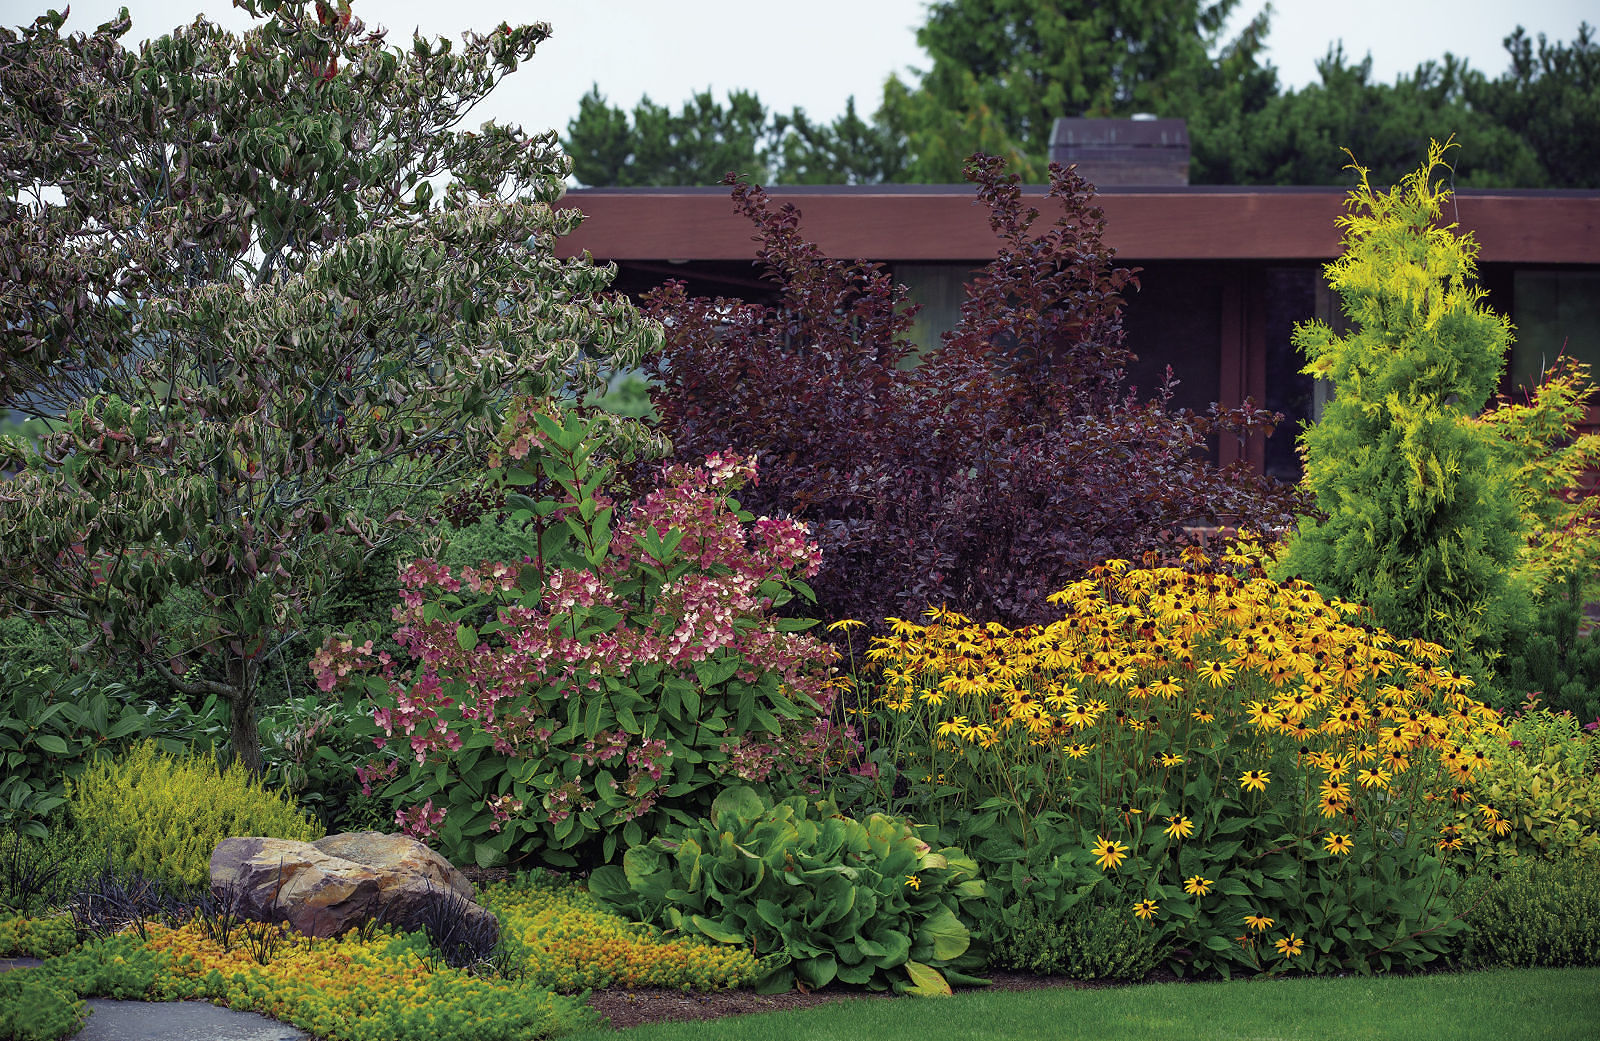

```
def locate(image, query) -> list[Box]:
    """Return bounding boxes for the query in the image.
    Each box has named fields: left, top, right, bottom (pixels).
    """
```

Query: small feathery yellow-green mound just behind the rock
left=70, top=742, right=323, bottom=886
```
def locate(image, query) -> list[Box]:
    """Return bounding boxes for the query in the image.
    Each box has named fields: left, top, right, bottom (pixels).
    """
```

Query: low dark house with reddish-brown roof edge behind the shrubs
left=563, top=163, right=1600, bottom=478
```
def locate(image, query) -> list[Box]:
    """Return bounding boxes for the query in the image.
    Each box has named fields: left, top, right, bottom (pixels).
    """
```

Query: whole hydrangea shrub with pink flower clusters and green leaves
left=314, top=401, right=848, bottom=867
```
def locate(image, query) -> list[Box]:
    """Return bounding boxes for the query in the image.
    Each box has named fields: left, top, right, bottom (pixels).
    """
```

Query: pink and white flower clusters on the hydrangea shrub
left=312, top=447, right=838, bottom=857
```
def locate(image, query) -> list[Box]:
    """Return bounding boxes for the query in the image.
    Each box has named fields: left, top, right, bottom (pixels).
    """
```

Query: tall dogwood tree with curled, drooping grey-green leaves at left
left=0, top=0, right=659, bottom=769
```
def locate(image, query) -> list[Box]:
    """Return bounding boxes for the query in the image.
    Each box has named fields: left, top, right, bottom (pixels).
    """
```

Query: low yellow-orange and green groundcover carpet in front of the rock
left=0, top=875, right=760, bottom=1041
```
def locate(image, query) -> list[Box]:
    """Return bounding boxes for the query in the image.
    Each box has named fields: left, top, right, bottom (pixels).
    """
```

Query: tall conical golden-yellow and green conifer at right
left=1280, top=144, right=1531, bottom=652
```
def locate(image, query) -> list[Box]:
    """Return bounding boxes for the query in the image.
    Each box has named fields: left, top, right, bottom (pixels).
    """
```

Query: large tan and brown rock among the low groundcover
left=211, top=832, right=498, bottom=943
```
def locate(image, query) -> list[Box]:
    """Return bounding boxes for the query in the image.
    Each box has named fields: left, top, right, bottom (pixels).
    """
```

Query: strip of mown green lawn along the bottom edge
left=570, top=969, right=1600, bottom=1041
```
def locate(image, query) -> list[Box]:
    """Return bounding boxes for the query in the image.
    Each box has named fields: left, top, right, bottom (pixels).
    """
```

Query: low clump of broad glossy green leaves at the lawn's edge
left=589, top=785, right=984, bottom=995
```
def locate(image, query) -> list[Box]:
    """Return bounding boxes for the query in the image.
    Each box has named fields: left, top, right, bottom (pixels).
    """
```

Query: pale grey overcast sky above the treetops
left=15, top=0, right=1600, bottom=140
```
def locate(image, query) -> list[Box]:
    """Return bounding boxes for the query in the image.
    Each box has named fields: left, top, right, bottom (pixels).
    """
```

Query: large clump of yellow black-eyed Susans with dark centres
left=825, top=542, right=1501, bottom=974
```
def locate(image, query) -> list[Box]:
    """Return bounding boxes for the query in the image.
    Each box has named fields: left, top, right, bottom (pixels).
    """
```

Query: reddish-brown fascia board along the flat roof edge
left=558, top=184, right=1600, bottom=264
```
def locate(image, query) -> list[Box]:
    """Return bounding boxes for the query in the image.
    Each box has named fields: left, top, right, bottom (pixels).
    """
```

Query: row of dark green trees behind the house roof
left=565, top=0, right=1600, bottom=189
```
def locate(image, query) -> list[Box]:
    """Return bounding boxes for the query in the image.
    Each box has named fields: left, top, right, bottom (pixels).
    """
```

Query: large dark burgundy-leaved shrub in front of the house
left=645, top=155, right=1294, bottom=624
